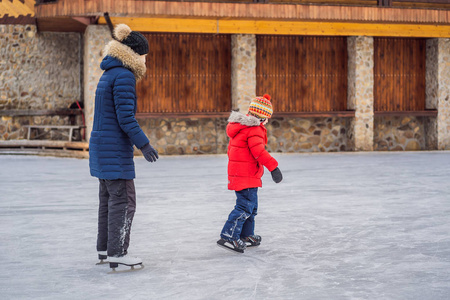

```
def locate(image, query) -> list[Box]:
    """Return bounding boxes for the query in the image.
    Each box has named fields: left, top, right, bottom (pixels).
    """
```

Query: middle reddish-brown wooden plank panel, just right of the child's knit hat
left=256, top=35, right=347, bottom=112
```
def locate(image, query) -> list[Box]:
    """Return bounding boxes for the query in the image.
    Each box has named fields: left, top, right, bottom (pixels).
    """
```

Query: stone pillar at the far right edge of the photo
left=426, top=39, right=450, bottom=150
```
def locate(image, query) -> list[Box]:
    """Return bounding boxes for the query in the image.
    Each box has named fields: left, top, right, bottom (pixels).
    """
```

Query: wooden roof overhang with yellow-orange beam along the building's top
left=36, top=0, right=450, bottom=37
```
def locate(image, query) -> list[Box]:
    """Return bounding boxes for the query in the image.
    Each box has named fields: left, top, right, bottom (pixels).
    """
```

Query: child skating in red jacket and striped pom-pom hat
left=217, top=94, right=283, bottom=253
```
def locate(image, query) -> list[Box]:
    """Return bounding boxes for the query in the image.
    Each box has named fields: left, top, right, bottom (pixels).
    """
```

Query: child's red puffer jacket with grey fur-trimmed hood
left=227, top=112, right=278, bottom=191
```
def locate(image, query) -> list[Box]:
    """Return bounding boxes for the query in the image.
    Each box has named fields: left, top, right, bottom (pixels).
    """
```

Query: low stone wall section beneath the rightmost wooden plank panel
left=374, top=116, right=428, bottom=151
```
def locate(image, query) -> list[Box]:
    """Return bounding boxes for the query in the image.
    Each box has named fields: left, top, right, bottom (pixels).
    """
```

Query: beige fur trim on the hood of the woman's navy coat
left=103, top=40, right=147, bottom=81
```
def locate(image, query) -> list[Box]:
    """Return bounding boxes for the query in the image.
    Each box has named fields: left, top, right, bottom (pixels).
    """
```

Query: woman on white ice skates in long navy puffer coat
left=89, top=24, right=158, bottom=268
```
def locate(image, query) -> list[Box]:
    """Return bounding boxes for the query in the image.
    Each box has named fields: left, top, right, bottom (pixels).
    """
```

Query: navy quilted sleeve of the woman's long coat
left=113, top=72, right=149, bottom=149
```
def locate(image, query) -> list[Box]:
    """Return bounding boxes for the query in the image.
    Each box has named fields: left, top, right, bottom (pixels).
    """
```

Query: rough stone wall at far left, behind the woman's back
left=0, top=25, right=81, bottom=140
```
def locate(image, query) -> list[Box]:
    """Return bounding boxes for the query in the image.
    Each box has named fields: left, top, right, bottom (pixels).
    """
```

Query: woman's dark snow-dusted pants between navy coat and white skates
left=97, top=179, right=136, bottom=256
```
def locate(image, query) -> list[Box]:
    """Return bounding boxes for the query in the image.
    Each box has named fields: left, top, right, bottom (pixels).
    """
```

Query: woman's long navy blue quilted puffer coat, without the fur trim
left=89, top=52, right=149, bottom=179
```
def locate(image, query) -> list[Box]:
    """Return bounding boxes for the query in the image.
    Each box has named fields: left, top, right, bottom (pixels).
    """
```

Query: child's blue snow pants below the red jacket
left=220, top=188, right=258, bottom=240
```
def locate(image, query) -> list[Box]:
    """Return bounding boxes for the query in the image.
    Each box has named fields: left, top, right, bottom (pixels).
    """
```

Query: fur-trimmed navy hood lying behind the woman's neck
left=100, top=40, right=147, bottom=81
